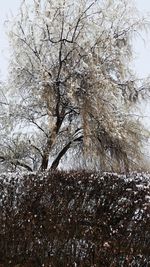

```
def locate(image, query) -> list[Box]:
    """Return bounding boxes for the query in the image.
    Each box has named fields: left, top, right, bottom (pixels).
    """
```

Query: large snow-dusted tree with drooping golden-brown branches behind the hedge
left=0, top=0, right=149, bottom=170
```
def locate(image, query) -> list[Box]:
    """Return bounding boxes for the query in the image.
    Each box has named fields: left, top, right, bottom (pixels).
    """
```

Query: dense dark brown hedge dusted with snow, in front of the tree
left=0, top=171, right=150, bottom=267
